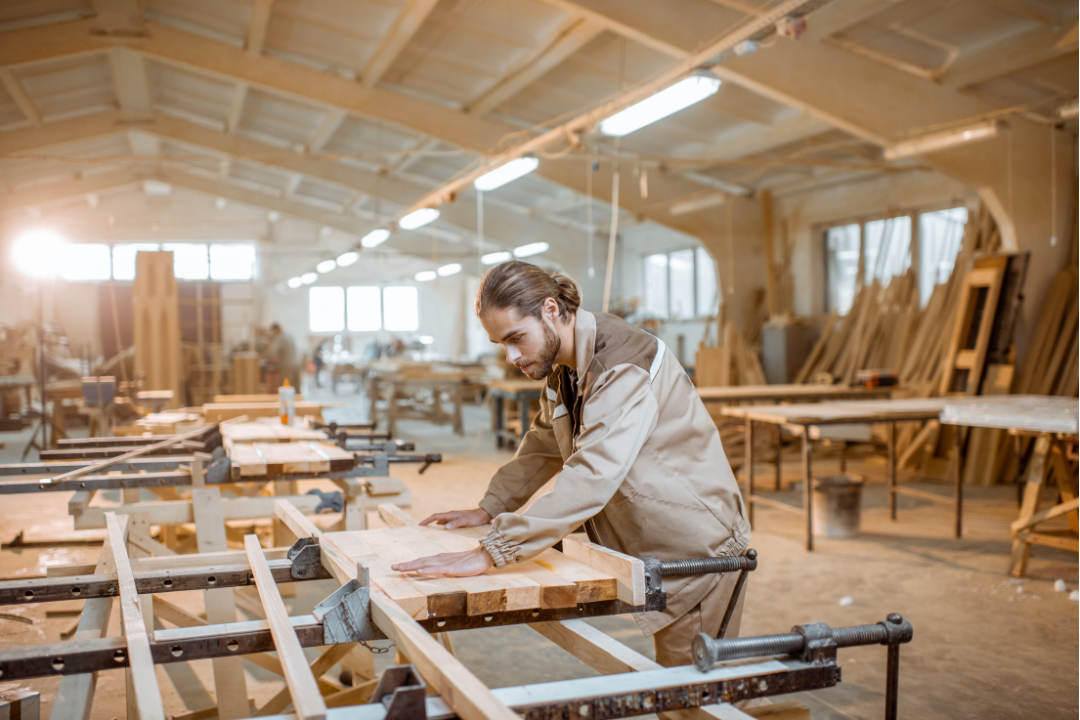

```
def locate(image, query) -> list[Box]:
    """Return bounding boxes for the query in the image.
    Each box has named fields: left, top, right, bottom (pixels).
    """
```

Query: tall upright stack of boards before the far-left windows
left=132, top=252, right=184, bottom=408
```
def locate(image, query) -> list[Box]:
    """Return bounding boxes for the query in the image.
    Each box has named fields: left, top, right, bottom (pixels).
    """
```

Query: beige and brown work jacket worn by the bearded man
left=480, top=310, right=750, bottom=635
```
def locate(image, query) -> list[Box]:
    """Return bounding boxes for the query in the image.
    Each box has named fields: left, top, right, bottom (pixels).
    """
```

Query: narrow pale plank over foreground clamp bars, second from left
left=244, top=534, right=326, bottom=720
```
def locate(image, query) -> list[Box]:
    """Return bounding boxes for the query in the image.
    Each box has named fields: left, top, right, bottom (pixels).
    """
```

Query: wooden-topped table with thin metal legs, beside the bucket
left=724, top=398, right=946, bottom=551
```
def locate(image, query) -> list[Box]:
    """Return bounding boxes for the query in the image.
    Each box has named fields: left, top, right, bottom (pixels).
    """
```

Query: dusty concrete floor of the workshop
left=0, top=393, right=1080, bottom=720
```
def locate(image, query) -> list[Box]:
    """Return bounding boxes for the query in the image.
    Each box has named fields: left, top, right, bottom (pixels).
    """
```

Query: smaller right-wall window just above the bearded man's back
left=645, top=247, right=719, bottom=320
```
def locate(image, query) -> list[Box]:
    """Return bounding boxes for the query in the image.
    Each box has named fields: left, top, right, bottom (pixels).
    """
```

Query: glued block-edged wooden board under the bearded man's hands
left=325, top=527, right=619, bottom=620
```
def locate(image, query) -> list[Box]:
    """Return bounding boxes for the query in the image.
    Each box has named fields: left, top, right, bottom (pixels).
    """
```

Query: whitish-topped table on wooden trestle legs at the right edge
left=941, top=395, right=1080, bottom=576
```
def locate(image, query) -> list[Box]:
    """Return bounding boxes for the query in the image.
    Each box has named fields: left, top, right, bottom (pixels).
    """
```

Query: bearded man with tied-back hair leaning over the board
left=394, top=261, right=750, bottom=666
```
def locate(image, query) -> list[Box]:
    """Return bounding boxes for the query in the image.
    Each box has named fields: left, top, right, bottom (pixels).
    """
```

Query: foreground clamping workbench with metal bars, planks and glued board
left=0, top=501, right=913, bottom=720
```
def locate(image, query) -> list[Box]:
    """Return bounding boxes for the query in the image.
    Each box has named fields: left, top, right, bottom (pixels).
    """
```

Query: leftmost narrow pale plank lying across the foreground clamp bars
left=105, top=513, right=165, bottom=720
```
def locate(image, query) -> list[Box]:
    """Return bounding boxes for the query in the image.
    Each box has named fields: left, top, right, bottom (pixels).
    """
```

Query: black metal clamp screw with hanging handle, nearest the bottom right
left=692, top=613, right=915, bottom=720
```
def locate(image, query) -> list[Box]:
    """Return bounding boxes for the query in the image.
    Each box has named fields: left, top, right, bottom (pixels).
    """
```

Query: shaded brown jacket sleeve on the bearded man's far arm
left=480, top=398, right=563, bottom=518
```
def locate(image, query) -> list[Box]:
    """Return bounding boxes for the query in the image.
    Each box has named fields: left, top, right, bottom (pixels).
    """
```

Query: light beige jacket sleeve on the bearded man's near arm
left=481, top=364, right=658, bottom=567
